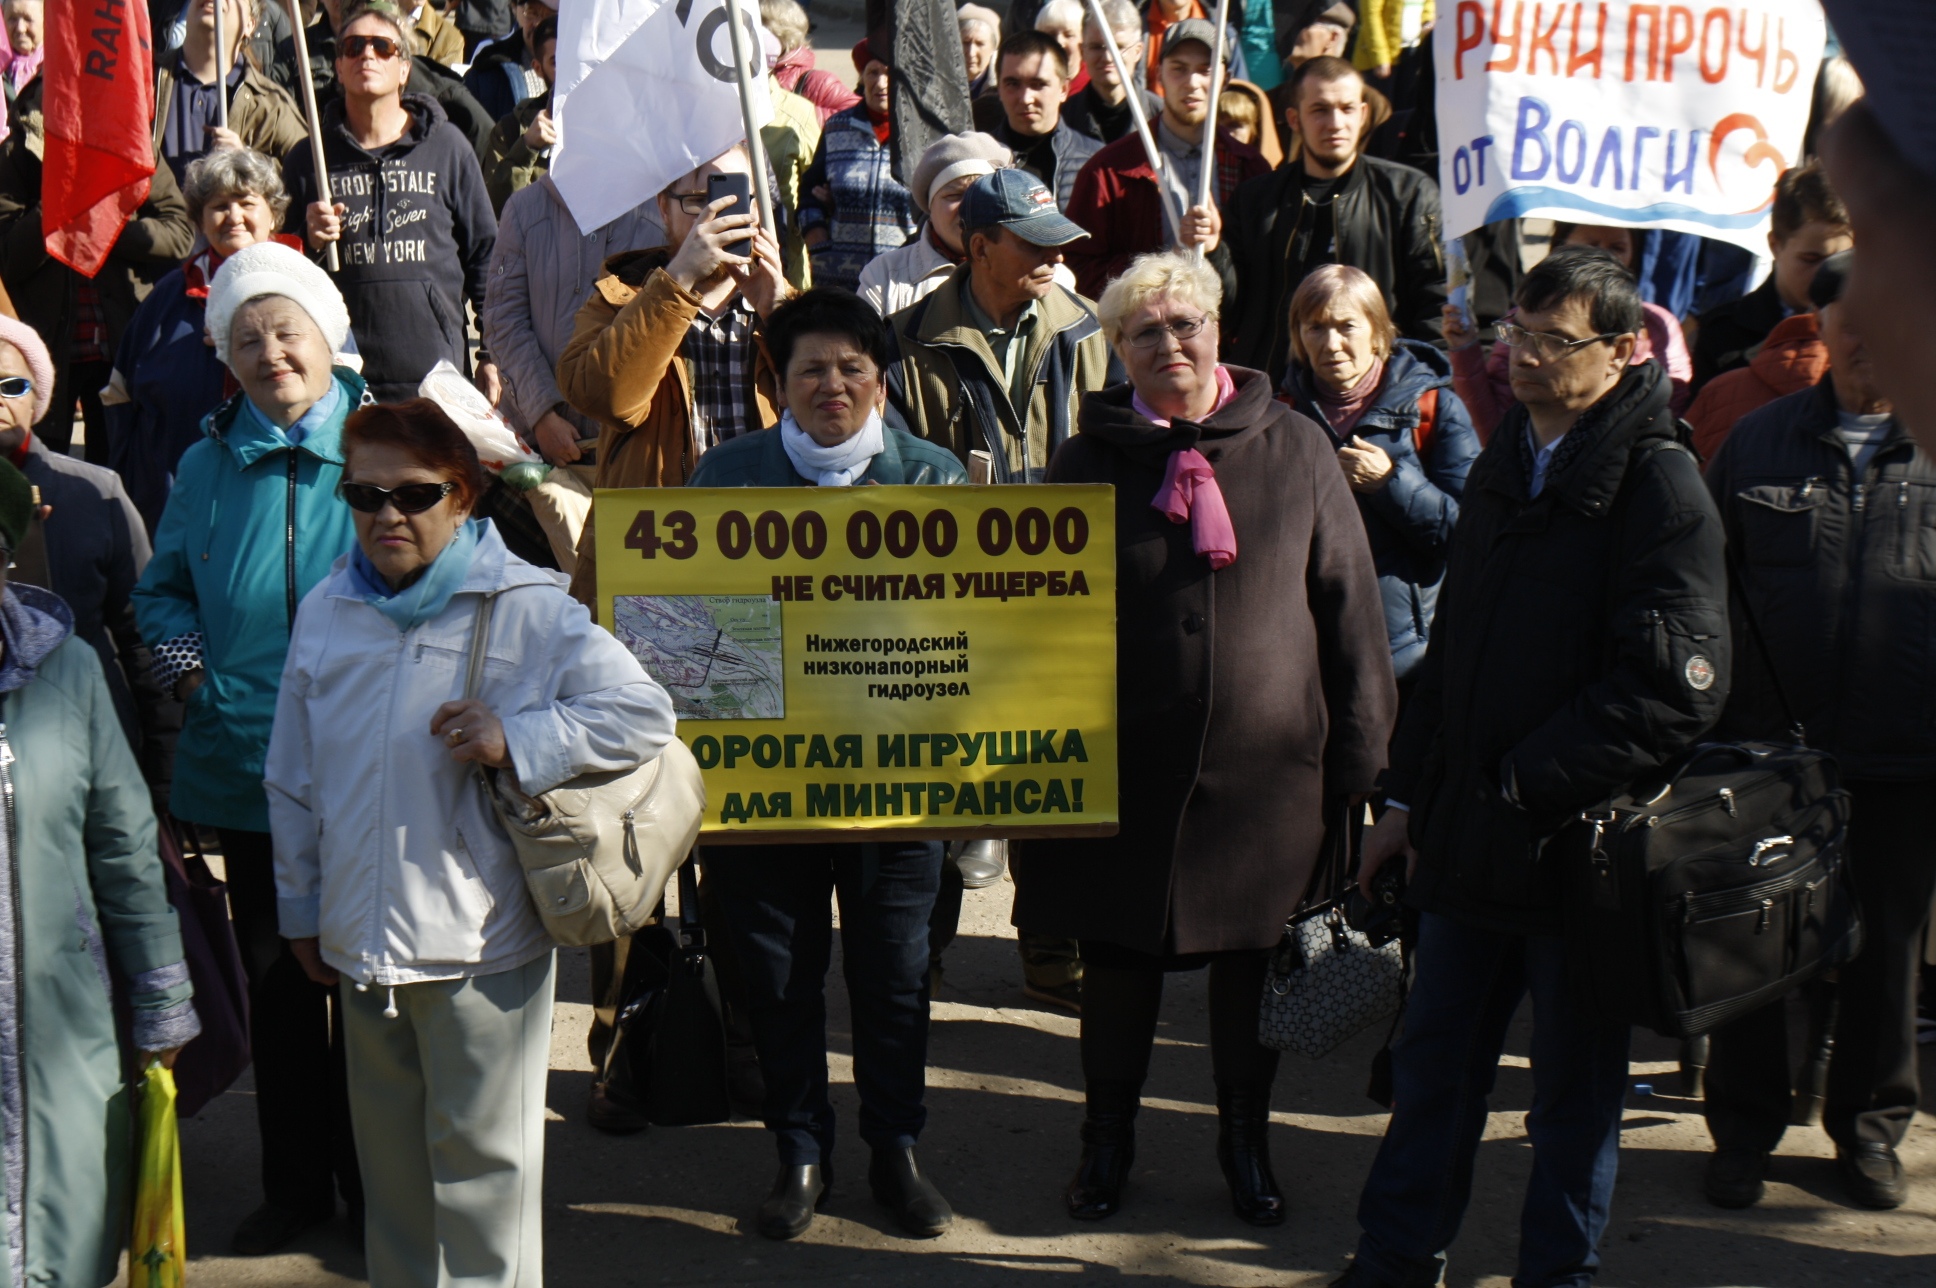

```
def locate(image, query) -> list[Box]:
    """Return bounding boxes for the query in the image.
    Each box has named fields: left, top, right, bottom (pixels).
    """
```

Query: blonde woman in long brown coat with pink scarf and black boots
left=1014, top=252, right=1396, bottom=1226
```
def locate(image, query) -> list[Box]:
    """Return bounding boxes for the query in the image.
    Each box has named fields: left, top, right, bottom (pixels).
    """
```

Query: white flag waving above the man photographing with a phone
left=552, top=0, right=772, bottom=232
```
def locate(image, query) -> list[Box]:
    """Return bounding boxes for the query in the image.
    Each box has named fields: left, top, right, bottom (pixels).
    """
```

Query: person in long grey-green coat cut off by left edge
left=0, top=461, right=199, bottom=1288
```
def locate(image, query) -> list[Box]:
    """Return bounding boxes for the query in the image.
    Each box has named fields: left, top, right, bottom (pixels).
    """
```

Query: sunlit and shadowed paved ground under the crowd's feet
left=162, top=885, right=1936, bottom=1288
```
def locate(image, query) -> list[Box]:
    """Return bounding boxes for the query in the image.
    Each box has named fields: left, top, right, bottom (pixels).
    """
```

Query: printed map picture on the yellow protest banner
left=612, top=595, right=786, bottom=721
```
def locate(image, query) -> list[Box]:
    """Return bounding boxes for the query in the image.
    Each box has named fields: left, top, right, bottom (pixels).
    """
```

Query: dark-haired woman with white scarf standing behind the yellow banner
left=687, top=287, right=968, bottom=1240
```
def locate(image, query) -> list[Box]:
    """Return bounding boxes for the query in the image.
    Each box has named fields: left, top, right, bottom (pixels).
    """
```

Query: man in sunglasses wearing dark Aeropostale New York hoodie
left=283, top=0, right=499, bottom=403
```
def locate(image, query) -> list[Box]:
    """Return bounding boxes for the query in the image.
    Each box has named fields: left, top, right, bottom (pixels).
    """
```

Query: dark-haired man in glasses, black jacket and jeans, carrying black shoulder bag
left=1338, top=248, right=1731, bottom=1288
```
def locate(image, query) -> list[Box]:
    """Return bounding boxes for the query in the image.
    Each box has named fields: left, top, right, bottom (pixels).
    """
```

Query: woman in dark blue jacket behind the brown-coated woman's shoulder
left=1278, top=263, right=1479, bottom=686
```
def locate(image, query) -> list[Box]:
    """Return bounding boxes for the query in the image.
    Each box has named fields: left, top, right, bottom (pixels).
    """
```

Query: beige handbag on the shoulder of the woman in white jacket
left=465, top=595, right=707, bottom=947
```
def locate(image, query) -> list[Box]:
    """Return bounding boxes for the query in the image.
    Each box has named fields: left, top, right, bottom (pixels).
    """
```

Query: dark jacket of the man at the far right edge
left=1708, top=371, right=1936, bottom=779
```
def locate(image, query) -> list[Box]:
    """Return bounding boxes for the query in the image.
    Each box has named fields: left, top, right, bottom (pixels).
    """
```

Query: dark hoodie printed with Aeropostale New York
left=283, top=93, right=498, bottom=403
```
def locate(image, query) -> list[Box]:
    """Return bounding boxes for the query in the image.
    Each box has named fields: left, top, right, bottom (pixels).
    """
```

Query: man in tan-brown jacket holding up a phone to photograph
left=558, top=145, right=788, bottom=616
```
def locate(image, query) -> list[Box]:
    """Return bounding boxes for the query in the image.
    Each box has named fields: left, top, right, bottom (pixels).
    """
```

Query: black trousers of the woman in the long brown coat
left=1082, top=939, right=1278, bottom=1089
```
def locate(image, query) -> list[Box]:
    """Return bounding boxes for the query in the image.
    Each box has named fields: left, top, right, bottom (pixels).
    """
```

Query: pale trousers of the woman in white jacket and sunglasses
left=341, top=953, right=558, bottom=1288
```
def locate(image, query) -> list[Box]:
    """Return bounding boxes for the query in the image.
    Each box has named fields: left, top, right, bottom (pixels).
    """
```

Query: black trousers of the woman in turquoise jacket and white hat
left=221, top=829, right=362, bottom=1212
